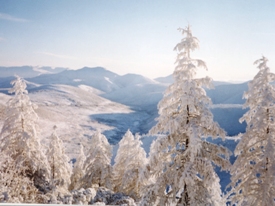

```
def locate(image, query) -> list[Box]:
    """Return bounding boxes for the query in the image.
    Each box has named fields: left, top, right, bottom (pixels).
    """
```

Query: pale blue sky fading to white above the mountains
left=0, top=0, right=275, bottom=81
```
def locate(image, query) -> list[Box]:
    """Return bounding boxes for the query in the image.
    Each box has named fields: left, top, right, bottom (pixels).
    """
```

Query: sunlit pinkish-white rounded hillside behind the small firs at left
left=0, top=85, right=133, bottom=156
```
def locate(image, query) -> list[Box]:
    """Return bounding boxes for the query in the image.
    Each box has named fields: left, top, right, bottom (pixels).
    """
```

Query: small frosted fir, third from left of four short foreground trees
left=81, top=130, right=112, bottom=189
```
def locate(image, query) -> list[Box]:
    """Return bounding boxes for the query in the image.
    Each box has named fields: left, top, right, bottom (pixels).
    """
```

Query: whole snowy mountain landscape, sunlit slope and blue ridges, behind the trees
left=0, top=67, right=250, bottom=147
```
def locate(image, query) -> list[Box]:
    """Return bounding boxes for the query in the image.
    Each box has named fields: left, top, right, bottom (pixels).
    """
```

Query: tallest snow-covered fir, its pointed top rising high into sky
left=141, top=26, right=230, bottom=205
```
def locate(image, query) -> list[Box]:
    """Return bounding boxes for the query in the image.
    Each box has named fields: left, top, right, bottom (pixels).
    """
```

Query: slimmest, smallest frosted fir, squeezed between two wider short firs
left=69, top=144, right=86, bottom=190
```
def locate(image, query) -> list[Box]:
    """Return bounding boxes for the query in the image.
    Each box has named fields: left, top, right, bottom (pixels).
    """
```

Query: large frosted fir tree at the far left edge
left=0, top=76, right=49, bottom=198
